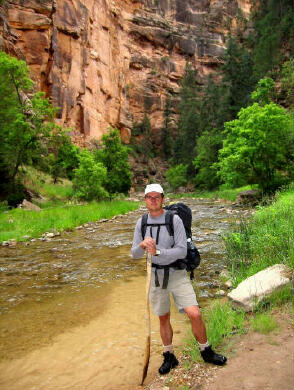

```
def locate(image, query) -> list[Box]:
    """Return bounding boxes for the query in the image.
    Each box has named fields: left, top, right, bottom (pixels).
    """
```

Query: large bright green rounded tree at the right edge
left=218, top=103, right=293, bottom=192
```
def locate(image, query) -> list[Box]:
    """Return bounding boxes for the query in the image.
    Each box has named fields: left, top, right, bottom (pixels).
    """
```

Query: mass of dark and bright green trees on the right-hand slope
left=131, top=0, right=294, bottom=192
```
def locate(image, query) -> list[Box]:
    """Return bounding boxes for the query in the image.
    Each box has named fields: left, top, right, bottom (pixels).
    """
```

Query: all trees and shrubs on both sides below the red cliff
left=0, top=0, right=294, bottom=206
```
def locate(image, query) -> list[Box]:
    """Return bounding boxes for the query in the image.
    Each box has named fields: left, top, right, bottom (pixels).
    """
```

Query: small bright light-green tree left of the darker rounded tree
left=73, top=149, right=109, bottom=201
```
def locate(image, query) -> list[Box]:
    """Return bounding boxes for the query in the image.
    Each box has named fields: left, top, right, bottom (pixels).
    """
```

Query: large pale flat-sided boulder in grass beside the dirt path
left=228, top=264, right=291, bottom=311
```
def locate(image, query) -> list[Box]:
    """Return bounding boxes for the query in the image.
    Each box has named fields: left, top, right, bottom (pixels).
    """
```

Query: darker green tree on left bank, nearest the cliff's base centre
left=94, top=129, right=132, bottom=195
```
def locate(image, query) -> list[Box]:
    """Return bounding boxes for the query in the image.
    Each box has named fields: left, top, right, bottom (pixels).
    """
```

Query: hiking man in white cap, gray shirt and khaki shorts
left=131, top=184, right=227, bottom=374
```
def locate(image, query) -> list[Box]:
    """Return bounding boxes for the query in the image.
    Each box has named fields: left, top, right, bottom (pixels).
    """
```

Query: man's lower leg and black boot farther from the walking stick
left=184, top=306, right=227, bottom=366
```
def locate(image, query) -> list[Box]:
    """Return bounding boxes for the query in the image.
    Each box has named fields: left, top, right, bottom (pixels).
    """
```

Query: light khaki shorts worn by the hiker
left=149, top=270, right=198, bottom=316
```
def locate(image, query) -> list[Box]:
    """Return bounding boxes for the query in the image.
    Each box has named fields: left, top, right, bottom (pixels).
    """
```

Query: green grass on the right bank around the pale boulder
left=184, top=187, right=294, bottom=368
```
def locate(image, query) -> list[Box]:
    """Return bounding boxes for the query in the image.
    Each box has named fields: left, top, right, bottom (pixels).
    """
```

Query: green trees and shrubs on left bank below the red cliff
left=0, top=52, right=131, bottom=206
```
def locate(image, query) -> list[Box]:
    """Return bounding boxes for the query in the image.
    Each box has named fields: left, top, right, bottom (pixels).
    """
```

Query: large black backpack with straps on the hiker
left=141, top=202, right=201, bottom=280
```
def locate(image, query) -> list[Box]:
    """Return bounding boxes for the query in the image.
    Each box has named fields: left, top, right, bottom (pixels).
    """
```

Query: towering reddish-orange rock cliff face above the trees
left=0, top=0, right=252, bottom=144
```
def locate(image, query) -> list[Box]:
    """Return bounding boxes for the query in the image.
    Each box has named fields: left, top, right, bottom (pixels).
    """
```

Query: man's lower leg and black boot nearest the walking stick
left=158, top=312, right=179, bottom=374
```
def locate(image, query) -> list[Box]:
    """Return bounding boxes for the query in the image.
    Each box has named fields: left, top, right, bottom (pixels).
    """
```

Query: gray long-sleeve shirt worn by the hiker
left=131, top=211, right=187, bottom=265
